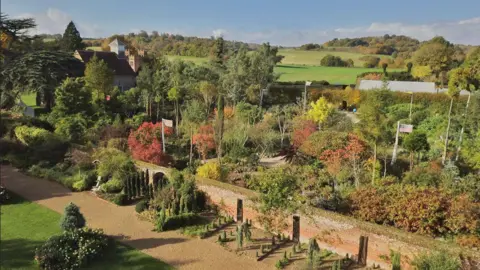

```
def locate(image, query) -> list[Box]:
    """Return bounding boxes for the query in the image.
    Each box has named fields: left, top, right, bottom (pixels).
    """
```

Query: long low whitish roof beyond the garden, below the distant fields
left=358, top=80, right=437, bottom=93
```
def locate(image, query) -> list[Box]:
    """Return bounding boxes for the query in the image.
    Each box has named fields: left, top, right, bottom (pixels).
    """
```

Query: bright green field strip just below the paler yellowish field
left=275, top=65, right=398, bottom=84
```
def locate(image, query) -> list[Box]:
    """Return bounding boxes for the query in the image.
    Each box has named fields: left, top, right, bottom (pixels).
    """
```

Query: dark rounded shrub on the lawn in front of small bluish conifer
left=35, top=228, right=109, bottom=270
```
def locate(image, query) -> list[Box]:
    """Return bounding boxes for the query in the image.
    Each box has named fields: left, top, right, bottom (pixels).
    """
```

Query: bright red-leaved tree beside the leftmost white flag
left=128, top=122, right=173, bottom=165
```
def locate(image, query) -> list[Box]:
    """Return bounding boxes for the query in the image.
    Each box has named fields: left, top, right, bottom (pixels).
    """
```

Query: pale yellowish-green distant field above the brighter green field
left=278, top=49, right=389, bottom=67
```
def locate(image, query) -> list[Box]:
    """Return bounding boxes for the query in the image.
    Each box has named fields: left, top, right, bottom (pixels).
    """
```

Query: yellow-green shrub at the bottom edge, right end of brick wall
left=412, top=251, right=462, bottom=270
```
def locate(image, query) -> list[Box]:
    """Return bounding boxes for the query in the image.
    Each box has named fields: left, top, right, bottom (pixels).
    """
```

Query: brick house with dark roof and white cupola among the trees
left=74, top=39, right=145, bottom=90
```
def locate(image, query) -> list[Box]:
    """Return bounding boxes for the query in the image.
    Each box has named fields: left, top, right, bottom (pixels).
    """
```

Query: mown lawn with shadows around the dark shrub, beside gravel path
left=0, top=194, right=173, bottom=270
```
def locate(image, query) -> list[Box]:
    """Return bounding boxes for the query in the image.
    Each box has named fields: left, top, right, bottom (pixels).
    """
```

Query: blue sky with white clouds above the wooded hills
left=0, top=0, right=480, bottom=46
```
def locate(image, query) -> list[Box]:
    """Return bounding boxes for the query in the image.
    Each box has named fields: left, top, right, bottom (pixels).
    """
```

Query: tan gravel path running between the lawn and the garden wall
left=0, top=165, right=273, bottom=270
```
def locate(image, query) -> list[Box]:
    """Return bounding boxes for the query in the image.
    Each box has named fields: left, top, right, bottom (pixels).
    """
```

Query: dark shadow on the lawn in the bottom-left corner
left=0, top=239, right=43, bottom=269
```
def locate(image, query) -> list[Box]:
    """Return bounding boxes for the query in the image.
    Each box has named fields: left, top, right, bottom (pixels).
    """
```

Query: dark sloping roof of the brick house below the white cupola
left=77, top=50, right=135, bottom=76
